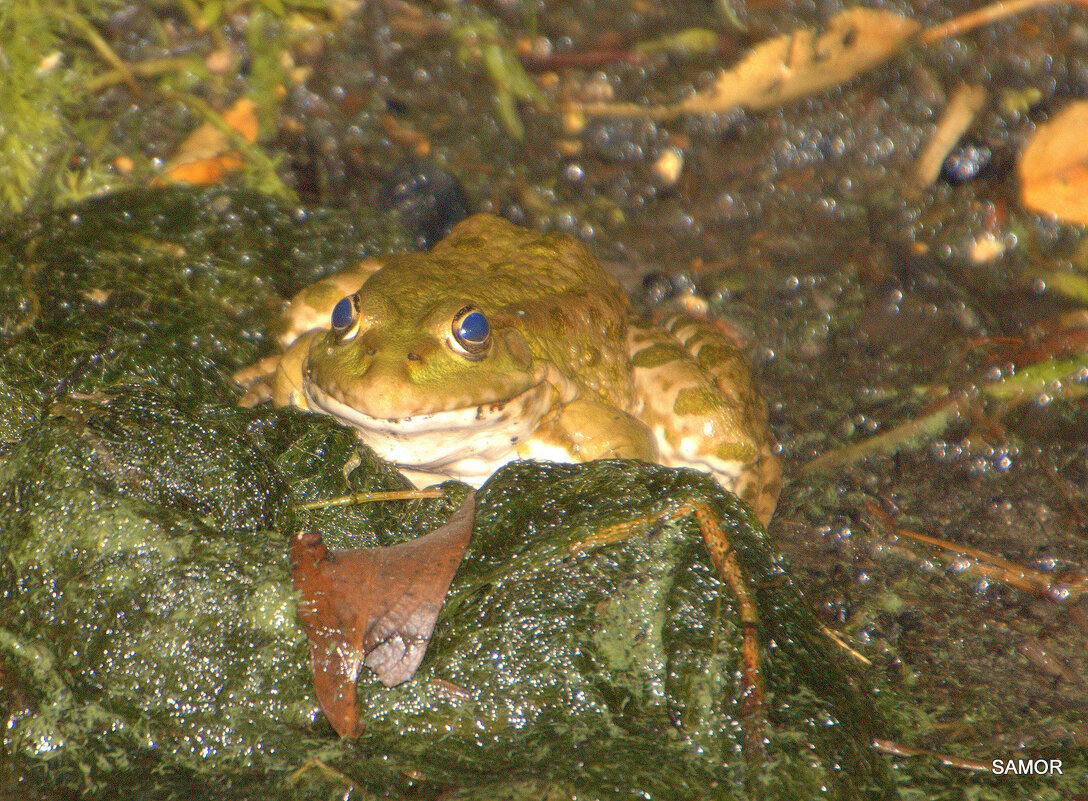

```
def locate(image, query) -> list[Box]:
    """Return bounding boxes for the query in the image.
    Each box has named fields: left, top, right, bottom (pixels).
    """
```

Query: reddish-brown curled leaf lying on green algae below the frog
left=290, top=494, right=474, bottom=737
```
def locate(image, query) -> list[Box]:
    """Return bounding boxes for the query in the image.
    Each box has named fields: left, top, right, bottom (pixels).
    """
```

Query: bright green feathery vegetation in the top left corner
left=0, top=0, right=317, bottom=217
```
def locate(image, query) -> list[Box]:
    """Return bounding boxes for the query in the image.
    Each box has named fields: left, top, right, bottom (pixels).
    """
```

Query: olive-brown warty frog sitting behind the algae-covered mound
left=235, top=213, right=781, bottom=523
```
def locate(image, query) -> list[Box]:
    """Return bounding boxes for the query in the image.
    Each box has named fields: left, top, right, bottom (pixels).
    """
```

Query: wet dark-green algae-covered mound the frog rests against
left=0, top=192, right=890, bottom=799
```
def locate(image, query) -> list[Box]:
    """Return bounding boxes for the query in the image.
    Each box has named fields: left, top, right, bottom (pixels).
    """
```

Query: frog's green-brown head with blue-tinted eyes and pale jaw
left=304, top=278, right=564, bottom=467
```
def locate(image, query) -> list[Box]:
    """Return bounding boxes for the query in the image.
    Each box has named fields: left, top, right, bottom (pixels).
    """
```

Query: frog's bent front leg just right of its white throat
left=518, top=398, right=657, bottom=461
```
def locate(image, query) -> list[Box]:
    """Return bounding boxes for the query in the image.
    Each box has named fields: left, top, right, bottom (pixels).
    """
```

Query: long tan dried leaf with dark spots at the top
left=583, top=8, right=920, bottom=119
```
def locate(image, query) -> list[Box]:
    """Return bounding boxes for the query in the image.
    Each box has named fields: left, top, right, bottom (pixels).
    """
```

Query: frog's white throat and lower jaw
left=306, top=381, right=559, bottom=485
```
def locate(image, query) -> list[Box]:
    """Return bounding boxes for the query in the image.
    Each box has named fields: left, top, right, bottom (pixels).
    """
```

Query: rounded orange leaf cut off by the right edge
left=1019, top=100, right=1088, bottom=225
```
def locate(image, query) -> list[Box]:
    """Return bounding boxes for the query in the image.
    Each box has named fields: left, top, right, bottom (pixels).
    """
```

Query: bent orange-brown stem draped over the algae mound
left=571, top=498, right=767, bottom=763
